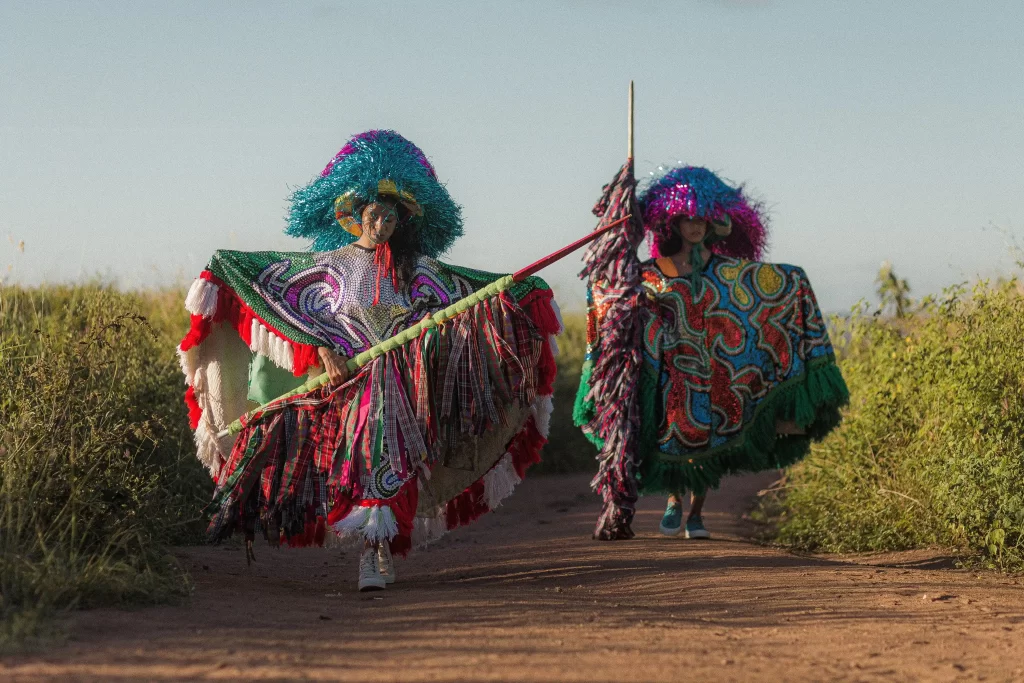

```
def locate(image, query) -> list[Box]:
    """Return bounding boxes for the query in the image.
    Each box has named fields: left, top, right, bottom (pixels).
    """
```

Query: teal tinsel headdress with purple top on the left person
left=285, top=130, right=462, bottom=257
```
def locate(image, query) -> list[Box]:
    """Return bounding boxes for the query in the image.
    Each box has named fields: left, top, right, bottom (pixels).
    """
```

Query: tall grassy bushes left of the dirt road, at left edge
left=0, top=286, right=209, bottom=637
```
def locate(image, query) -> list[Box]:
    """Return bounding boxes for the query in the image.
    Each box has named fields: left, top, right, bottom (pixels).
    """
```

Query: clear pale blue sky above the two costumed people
left=0, top=0, right=1024, bottom=311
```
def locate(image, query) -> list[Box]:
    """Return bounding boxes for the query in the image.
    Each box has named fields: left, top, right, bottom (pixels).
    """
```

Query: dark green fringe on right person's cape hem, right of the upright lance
left=637, top=355, right=850, bottom=496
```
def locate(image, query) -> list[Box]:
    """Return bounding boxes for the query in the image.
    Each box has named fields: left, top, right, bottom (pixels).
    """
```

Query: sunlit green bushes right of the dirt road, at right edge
left=765, top=283, right=1024, bottom=568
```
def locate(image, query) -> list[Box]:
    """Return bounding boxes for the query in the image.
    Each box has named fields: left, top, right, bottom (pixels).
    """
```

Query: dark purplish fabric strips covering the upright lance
left=580, top=159, right=643, bottom=540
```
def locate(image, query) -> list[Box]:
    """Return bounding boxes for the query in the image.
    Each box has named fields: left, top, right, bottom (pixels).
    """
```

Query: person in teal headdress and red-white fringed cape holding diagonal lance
left=179, top=130, right=560, bottom=590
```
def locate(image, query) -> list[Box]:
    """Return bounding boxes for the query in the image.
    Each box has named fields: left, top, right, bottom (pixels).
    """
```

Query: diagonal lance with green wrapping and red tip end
left=217, top=215, right=631, bottom=437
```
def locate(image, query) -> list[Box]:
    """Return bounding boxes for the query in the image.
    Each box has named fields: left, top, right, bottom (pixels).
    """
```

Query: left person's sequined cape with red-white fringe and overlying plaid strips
left=179, top=245, right=560, bottom=552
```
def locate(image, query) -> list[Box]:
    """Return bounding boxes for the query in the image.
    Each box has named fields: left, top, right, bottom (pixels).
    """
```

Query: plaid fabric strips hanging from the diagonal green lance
left=208, top=291, right=559, bottom=545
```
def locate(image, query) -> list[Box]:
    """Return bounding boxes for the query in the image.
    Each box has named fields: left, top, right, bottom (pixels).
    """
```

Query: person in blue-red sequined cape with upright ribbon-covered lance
left=573, top=159, right=849, bottom=540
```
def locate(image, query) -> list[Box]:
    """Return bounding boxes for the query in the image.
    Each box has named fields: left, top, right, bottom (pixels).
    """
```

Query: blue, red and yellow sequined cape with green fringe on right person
left=574, top=255, right=848, bottom=494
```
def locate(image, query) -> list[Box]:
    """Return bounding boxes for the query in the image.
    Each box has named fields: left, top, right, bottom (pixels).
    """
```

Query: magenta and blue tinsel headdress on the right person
left=638, top=166, right=768, bottom=260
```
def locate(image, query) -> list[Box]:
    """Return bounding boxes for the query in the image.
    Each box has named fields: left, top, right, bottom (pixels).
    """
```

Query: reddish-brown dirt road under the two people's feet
left=0, top=476, right=1024, bottom=683
